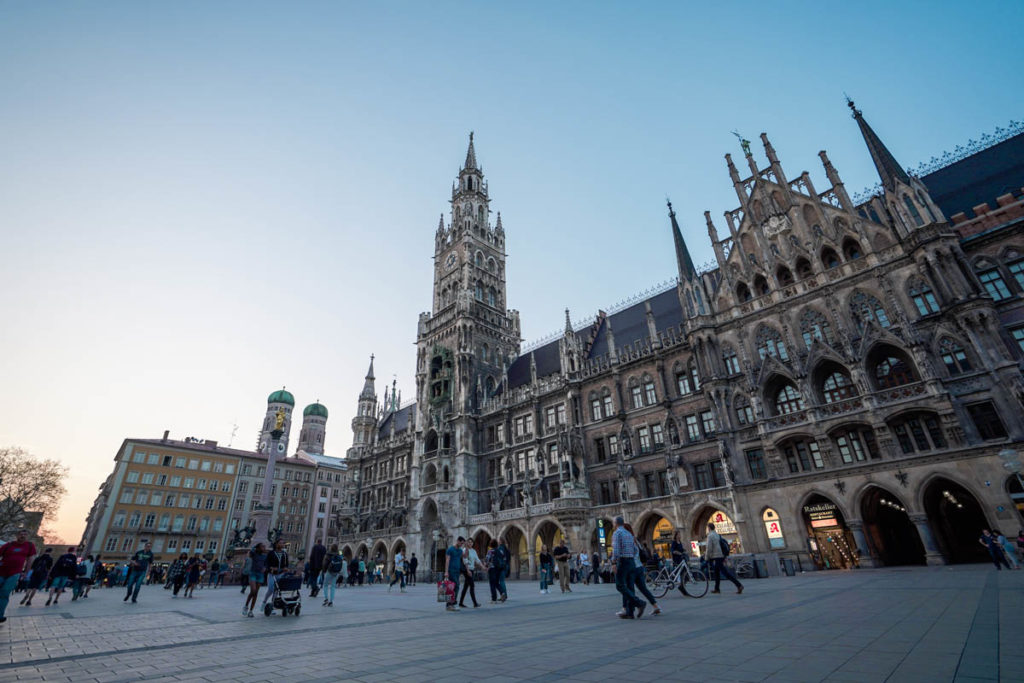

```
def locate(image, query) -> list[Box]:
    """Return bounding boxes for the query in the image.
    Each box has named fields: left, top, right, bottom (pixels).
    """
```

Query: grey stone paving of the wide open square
left=0, top=565, right=1024, bottom=683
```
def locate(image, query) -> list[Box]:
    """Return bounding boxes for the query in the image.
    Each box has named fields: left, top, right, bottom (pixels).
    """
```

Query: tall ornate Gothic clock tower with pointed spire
left=411, top=133, right=520, bottom=547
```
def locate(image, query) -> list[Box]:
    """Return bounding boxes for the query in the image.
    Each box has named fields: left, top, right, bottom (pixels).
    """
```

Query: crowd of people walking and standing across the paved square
left=8, top=517, right=1024, bottom=624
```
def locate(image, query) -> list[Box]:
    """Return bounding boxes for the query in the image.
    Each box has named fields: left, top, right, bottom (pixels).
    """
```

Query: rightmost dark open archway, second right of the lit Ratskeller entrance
left=924, top=477, right=988, bottom=564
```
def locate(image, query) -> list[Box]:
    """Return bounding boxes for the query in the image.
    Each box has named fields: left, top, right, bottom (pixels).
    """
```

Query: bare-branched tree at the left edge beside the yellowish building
left=0, top=446, right=68, bottom=539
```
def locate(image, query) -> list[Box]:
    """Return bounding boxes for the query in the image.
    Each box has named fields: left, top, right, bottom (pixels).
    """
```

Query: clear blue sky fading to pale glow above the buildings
left=0, top=1, right=1024, bottom=540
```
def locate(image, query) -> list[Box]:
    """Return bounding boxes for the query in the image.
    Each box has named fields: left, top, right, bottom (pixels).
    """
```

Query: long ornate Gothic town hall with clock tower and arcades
left=337, top=107, right=1024, bottom=578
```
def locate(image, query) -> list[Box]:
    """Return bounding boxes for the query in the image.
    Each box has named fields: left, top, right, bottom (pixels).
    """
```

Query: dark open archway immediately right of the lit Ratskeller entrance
left=860, top=486, right=925, bottom=566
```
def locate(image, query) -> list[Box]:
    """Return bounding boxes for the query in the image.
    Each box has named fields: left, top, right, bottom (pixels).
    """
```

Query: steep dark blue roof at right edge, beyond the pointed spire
left=921, top=133, right=1024, bottom=218
